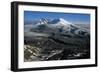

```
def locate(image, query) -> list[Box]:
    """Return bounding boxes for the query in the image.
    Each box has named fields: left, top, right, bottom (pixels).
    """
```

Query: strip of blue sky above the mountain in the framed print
left=24, top=11, right=90, bottom=24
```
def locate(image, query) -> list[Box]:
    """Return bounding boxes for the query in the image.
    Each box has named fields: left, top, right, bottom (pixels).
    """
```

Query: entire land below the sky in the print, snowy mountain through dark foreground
left=24, top=18, right=90, bottom=62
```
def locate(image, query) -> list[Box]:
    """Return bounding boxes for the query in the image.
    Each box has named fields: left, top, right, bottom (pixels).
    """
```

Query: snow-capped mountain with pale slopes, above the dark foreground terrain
left=25, top=18, right=90, bottom=37
